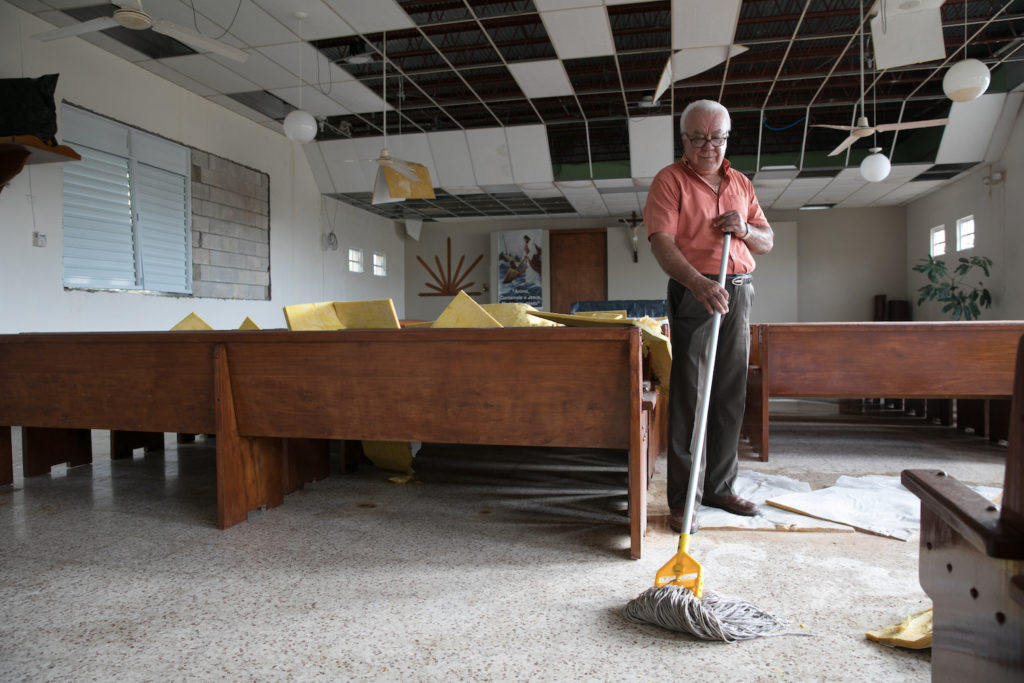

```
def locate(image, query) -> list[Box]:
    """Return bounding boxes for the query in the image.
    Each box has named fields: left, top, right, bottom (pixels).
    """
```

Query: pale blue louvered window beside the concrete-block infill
left=60, top=104, right=191, bottom=294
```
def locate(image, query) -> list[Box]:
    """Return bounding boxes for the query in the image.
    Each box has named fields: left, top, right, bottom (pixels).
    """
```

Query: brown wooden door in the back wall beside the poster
left=545, top=227, right=608, bottom=313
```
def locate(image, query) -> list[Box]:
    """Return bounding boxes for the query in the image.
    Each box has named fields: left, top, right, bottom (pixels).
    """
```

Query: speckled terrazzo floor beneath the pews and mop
left=0, top=404, right=1006, bottom=681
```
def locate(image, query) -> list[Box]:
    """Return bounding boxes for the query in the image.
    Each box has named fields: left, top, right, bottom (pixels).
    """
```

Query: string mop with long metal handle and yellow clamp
left=623, top=232, right=784, bottom=642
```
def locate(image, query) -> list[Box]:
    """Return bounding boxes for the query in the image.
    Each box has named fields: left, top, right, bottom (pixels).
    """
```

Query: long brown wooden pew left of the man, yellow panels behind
left=0, top=328, right=648, bottom=558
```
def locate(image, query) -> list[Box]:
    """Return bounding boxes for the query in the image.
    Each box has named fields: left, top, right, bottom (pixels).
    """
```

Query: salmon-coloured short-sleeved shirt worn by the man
left=643, top=159, right=768, bottom=274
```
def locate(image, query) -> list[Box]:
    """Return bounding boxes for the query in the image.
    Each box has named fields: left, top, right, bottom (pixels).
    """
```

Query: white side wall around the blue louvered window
left=0, top=3, right=404, bottom=333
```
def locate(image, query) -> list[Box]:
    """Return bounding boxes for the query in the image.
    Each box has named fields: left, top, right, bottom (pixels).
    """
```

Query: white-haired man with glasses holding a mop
left=644, top=99, right=774, bottom=533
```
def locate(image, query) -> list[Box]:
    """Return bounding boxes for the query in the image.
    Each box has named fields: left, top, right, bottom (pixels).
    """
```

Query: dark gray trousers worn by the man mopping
left=668, top=278, right=754, bottom=509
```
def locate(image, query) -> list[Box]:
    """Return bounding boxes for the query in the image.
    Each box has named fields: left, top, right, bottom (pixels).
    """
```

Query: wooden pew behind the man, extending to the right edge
left=744, top=322, right=1024, bottom=461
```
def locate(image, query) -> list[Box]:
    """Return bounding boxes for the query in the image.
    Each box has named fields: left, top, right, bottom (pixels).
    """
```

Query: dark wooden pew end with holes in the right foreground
left=901, top=340, right=1024, bottom=683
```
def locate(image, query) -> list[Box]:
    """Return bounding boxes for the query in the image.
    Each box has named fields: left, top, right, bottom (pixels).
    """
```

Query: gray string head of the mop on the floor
left=623, top=584, right=785, bottom=642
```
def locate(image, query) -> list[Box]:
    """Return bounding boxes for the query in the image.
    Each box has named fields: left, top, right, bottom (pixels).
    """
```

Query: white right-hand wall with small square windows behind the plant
left=904, top=100, right=1024, bottom=321
